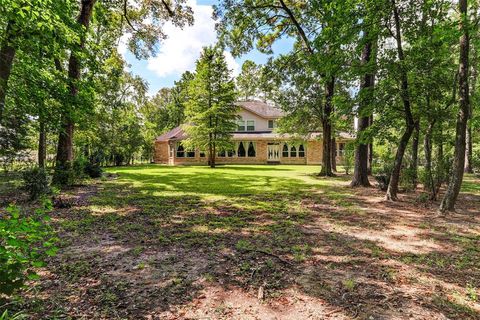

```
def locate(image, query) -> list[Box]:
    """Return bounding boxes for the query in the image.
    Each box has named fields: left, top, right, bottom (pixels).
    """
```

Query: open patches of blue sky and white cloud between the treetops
left=118, top=0, right=292, bottom=95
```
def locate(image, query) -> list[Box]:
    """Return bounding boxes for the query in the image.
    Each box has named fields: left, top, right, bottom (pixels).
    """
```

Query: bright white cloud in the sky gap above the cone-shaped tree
left=147, top=0, right=240, bottom=77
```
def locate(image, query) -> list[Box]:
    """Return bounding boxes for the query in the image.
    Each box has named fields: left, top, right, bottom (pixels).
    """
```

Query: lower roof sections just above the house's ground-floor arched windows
left=155, top=127, right=354, bottom=141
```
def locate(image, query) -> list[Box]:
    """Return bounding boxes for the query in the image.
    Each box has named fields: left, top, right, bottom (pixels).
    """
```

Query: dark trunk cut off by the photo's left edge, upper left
left=0, top=21, right=15, bottom=123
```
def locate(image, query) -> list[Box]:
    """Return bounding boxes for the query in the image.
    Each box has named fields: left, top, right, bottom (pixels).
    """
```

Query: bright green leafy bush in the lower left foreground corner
left=0, top=200, right=57, bottom=295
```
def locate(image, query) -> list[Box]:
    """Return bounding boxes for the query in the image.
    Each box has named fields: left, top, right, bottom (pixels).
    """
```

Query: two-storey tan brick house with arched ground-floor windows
left=154, top=101, right=352, bottom=165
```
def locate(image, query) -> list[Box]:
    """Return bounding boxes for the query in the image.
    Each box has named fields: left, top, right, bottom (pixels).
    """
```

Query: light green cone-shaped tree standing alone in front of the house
left=183, top=47, right=237, bottom=168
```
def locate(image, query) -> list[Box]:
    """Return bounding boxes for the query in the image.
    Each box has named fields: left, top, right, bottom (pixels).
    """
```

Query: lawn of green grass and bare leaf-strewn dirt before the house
left=7, top=165, right=480, bottom=319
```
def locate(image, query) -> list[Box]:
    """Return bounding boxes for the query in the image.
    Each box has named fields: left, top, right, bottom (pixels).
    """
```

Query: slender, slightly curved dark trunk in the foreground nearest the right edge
left=439, top=0, right=470, bottom=214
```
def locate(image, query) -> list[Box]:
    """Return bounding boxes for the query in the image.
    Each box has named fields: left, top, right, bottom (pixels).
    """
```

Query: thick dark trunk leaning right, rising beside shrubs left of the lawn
left=56, top=0, right=96, bottom=174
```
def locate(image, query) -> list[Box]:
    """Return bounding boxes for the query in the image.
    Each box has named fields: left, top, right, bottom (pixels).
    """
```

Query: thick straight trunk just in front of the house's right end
left=350, top=37, right=375, bottom=187
